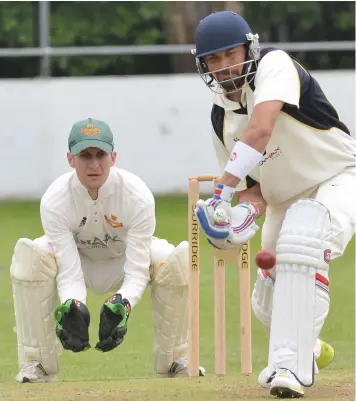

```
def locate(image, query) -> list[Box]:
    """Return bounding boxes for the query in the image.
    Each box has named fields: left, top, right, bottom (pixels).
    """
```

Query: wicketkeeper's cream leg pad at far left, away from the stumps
left=10, top=238, right=59, bottom=375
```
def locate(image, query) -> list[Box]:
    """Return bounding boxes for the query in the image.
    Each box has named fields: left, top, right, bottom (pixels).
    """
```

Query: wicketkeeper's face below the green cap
left=67, top=148, right=116, bottom=190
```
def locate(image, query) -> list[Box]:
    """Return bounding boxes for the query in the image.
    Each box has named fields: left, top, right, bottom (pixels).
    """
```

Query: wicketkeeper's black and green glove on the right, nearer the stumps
left=95, top=294, right=131, bottom=352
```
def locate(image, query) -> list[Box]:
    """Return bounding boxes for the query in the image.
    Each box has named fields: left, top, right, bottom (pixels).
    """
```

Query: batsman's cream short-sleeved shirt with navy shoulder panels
left=212, top=50, right=356, bottom=205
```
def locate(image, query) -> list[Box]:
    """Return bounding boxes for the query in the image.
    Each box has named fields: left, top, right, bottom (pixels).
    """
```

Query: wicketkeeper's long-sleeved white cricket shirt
left=41, top=167, right=156, bottom=307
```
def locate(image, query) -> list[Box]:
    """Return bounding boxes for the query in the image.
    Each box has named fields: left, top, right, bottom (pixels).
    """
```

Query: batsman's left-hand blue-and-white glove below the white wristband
left=195, top=184, right=235, bottom=240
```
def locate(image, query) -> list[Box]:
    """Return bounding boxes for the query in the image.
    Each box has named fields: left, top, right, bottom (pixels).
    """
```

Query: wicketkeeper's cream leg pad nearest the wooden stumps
left=151, top=241, right=189, bottom=375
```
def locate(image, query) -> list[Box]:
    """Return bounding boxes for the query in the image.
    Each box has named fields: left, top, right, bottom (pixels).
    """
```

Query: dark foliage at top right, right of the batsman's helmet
left=244, top=1, right=355, bottom=69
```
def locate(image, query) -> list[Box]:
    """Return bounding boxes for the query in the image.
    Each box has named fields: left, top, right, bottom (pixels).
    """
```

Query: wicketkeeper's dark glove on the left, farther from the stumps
left=55, top=299, right=90, bottom=352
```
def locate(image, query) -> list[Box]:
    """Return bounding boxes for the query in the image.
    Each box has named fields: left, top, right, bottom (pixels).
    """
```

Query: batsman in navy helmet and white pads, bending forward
left=193, top=11, right=356, bottom=398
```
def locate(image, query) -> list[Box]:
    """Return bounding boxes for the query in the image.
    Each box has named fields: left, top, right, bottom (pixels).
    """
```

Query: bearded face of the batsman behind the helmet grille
left=204, top=46, right=246, bottom=91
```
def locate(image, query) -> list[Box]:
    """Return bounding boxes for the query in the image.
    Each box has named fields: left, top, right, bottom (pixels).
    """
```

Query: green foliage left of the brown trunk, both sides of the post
left=0, top=1, right=168, bottom=77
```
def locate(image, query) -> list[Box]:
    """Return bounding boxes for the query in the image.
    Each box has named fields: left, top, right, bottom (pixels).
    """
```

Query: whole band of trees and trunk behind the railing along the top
left=0, top=1, right=355, bottom=77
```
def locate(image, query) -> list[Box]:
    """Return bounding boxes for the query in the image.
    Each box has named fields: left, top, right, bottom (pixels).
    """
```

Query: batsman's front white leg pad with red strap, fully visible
left=268, top=199, right=332, bottom=386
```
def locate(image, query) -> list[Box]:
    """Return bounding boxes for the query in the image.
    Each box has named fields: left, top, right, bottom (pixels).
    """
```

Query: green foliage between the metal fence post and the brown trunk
left=51, top=1, right=165, bottom=75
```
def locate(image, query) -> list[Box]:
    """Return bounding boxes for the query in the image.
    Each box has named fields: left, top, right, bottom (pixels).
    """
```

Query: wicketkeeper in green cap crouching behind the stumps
left=10, top=119, right=204, bottom=383
